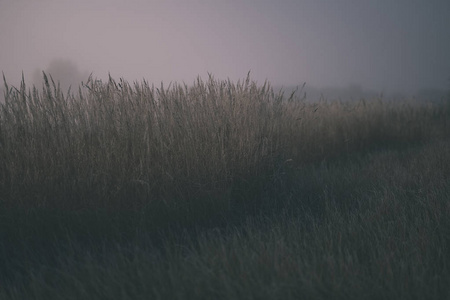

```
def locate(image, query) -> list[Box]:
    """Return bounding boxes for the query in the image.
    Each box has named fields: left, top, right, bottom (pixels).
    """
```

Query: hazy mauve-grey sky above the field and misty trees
left=0, top=0, right=450, bottom=92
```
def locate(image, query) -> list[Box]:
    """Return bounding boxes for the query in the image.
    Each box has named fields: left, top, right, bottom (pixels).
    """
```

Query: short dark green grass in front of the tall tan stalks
left=0, top=140, right=450, bottom=299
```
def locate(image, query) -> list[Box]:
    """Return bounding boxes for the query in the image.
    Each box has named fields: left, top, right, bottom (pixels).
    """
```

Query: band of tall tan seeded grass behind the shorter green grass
left=0, top=74, right=449, bottom=213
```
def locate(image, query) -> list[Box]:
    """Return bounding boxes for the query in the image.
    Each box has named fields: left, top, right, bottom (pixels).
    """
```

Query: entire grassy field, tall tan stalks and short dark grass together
left=0, top=74, right=450, bottom=299
